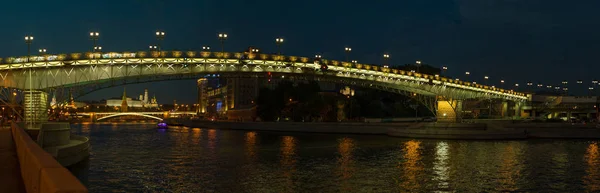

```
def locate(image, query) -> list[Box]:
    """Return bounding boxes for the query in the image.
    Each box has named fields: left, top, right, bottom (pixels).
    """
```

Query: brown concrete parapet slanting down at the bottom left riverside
left=11, top=123, right=88, bottom=193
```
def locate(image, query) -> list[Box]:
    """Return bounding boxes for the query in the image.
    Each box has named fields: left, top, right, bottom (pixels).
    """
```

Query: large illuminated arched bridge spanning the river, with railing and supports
left=0, top=51, right=528, bottom=120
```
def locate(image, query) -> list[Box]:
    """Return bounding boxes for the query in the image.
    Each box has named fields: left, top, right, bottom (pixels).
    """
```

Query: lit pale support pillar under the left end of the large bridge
left=23, top=90, right=48, bottom=128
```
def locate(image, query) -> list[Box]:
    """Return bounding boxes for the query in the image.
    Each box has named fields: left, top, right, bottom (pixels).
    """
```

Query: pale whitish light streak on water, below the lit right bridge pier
left=433, top=141, right=450, bottom=190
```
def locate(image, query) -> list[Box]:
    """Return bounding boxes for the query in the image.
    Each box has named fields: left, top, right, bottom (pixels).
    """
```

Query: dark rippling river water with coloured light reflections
left=70, top=124, right=600, bottom=192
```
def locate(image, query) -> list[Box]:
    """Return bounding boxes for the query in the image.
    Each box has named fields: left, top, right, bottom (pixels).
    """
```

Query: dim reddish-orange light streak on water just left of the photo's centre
left=280, top=136, right=296, bottom=192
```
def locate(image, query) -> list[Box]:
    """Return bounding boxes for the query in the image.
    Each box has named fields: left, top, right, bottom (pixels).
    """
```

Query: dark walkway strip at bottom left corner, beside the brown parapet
left=0, top=128, right=25, bottom=193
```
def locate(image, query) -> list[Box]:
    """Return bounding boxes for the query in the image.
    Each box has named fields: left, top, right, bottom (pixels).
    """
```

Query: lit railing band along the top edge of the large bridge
left=0, top=51, right=525, bottom=98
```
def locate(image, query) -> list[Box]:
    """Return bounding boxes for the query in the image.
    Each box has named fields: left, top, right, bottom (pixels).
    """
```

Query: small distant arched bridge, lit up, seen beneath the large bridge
left=77, top=111, right=196, bottom=121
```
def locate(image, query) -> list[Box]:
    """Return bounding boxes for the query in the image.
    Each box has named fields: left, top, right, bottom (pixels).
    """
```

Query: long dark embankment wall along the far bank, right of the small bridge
left=176, top=120, right=600, bottom=140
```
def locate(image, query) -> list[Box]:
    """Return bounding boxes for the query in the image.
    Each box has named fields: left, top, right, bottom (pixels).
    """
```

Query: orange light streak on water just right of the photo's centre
left=337, top=137, right=354, bottom=191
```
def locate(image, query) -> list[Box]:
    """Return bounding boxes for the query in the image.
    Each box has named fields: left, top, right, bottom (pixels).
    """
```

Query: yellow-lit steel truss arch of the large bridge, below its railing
left=0, top=58, right=526, bottom=119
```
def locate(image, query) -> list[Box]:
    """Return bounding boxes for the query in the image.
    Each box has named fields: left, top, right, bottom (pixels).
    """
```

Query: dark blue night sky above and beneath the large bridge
left=0, top=0, right=600, bottom=102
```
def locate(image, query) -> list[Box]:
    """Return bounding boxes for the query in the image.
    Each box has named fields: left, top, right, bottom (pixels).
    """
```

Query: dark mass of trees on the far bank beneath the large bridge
left=257, top=81, right=431, bottom=122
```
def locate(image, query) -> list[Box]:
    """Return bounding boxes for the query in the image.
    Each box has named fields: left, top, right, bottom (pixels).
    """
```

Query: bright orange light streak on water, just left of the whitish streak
left=400, top=140, right=423, bottom=191
